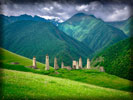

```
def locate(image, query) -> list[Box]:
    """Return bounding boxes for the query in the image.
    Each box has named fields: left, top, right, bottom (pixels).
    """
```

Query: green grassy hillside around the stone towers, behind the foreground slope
left=0, top=49, right=133, bottom=91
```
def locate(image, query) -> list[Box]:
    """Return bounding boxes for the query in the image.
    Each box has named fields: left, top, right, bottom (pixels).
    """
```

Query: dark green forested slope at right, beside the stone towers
left=91, top=38, right=133, bottom=80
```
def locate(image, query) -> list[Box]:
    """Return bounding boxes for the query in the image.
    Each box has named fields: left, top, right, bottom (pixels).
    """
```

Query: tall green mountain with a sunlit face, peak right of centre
left=58, top=13, right=127, bottom=51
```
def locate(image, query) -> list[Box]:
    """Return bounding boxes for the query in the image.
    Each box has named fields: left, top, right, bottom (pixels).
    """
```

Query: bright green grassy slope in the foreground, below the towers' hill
left=0, top=69, right=131, bottom=100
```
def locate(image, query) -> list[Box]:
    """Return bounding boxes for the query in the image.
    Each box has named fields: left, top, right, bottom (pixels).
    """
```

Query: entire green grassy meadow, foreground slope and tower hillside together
left=0, top=48, right=133, bottom=100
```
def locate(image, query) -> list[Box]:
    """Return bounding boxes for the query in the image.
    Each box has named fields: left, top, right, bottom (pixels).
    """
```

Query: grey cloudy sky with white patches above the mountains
left=1, top=0, right=132, bottom=22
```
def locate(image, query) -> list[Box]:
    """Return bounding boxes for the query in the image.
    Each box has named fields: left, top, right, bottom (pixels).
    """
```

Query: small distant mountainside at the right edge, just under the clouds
left=107, top=16, right=133, bottom=36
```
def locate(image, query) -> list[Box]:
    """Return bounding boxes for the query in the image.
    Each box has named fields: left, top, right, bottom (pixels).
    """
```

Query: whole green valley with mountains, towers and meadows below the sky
left=0, top=10, right=133, bottom=100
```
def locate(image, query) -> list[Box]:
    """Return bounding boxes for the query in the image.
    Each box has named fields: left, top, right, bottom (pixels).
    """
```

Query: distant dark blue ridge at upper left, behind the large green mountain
left=0, top=14, right=58, bottom=25
